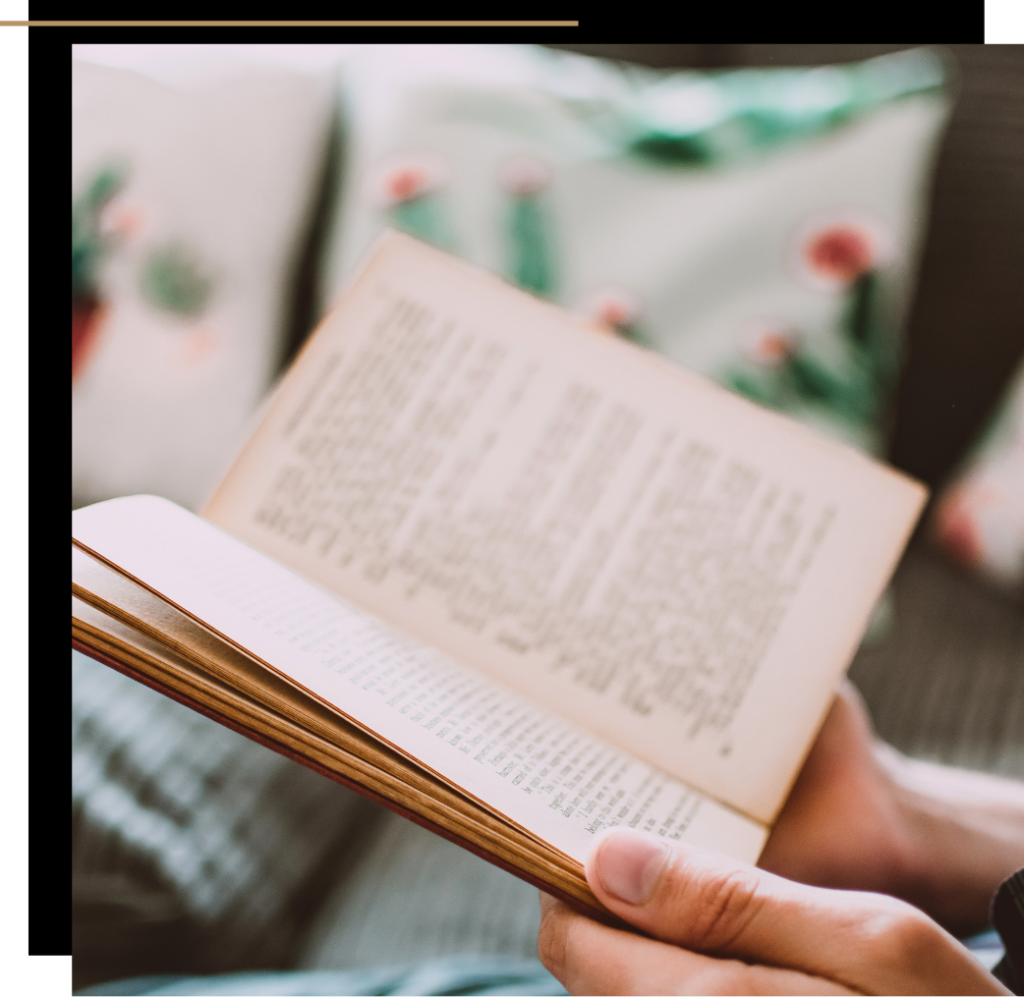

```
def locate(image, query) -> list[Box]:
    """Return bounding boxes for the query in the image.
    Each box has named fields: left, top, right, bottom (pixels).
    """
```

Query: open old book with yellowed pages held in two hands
left=72, top=232, right=925, bottom=925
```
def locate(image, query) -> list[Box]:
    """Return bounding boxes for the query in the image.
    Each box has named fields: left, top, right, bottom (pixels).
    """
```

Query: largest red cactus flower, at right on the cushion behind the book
left=795, top=214, right=892, bottom=291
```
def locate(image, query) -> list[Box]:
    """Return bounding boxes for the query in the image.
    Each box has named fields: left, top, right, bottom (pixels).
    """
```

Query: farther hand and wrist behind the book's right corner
left=758, top=683, right=1024, bottom=936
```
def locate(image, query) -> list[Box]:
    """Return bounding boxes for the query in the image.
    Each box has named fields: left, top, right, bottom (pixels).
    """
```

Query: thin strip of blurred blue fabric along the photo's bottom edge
left=78, top=955, right=567, bottom=997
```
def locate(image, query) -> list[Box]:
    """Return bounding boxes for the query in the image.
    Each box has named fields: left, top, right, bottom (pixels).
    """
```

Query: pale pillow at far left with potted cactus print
left=72, top=45, right=332, bottom=509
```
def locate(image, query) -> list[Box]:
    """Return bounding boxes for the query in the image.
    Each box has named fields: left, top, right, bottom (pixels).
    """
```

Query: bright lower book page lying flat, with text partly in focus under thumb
left=73, top=496, right=767, bottom=862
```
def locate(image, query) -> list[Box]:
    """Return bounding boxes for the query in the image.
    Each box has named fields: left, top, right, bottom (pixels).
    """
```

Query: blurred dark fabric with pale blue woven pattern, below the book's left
left=72, top=652, right=377, bottom=988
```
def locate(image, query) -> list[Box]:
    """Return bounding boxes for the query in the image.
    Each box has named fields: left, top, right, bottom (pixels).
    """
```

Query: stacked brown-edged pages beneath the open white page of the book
left=72, top=585, right=603, bottom=909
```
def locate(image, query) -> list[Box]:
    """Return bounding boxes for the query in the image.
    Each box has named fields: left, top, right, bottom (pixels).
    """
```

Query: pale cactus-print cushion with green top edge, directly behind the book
left=326, top=46, right=948, bottom=452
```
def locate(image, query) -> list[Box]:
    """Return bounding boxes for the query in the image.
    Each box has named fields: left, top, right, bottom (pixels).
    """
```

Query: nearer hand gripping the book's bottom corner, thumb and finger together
left=538, top=828, right=1009, bottom=994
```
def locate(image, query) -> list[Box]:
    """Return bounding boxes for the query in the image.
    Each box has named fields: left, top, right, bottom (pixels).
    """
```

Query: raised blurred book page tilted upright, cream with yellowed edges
left=206, top=234, right=924, bottom=822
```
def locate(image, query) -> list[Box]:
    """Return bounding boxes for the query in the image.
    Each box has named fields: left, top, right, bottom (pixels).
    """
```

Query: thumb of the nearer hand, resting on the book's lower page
left=587, top=828, right=994, bottom=994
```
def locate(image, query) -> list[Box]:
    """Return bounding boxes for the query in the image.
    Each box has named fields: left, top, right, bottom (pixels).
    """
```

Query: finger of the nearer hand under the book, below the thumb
left=538, top=896, right=853, bottom=994
